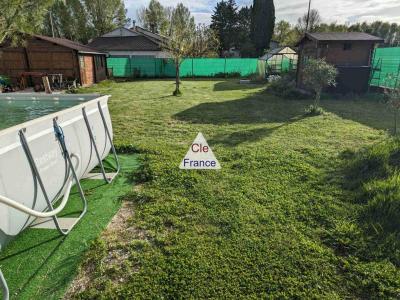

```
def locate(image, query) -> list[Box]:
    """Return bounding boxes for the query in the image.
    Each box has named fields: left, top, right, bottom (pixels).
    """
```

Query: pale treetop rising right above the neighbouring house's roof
left=137, top=0, right=172, bottom=35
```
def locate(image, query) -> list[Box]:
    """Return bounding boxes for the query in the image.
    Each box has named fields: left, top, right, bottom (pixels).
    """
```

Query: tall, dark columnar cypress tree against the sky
left=252, top=0, right=275, bottom=56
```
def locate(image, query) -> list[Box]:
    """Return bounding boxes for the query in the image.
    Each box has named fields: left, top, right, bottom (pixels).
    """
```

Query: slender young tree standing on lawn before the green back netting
left=165, top=3, right=196, bottom=96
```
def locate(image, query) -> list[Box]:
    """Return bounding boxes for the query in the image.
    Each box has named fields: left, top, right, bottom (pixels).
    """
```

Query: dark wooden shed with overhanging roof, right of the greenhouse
left=297, top=32, right=384, bottom=93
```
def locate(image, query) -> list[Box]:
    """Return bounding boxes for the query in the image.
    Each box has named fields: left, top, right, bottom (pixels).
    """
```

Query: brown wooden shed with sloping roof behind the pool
left=0, top=35, right=107, bottom=86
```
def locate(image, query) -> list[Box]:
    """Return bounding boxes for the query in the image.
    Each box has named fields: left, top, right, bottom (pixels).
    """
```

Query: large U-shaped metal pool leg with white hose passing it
left=19, top=119, right=87, bottom=235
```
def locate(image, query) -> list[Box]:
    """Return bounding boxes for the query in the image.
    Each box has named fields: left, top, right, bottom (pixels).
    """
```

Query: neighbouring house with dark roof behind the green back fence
left=88, top=26, right=169, bottom=58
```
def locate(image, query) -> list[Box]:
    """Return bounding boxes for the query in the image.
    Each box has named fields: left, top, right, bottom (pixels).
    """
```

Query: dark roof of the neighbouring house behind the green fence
left=88, top=35, right=161, bottom=51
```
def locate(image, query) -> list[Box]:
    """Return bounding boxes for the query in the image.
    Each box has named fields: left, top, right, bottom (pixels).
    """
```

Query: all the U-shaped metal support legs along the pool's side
left=0, top=97, right=121, bottom=300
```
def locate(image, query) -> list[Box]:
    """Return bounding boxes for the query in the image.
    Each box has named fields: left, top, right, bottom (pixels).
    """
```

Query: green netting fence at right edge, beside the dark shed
left=370, top=47, right=400, bottom=88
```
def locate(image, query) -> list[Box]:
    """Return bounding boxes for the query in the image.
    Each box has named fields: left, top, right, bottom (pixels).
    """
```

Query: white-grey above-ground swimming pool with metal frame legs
left=0, top=94, right=118, bottom=299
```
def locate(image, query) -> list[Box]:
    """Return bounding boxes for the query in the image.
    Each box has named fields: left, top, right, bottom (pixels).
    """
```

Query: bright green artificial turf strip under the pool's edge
left=0, top=155, right=139, bottom=299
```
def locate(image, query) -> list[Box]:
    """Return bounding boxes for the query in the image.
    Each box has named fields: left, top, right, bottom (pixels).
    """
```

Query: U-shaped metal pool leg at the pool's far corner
left=82, top=102, right=121, bottom=183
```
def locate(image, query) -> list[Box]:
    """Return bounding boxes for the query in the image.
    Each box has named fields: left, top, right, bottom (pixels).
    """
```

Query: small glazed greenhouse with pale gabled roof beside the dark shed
left=259, top=47, right=298, bottom=75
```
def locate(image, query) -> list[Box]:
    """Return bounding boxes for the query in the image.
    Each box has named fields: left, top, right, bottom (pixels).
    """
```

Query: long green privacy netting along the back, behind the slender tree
left=107, top=57, right=265, bottom=78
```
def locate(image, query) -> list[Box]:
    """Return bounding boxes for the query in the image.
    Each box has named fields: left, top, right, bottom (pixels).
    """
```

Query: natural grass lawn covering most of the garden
left=69, top=80, right=400, bottom=299
